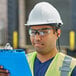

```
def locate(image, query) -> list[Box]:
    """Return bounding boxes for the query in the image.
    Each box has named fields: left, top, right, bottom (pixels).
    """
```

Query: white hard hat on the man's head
left=25, top=2, right=63, bottom=26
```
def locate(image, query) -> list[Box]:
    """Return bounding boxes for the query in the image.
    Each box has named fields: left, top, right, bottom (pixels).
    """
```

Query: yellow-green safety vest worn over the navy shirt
left=28, top=52, right=76, bottom=76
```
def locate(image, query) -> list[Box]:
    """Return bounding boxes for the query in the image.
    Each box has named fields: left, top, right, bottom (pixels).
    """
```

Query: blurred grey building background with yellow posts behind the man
left=0, top=0, right=76, bottom=57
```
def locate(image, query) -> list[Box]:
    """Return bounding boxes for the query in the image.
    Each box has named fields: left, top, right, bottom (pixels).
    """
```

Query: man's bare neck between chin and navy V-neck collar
left=37, top=48, right=58, bottom=63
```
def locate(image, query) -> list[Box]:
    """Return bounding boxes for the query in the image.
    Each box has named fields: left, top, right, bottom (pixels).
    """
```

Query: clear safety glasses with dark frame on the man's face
left=29, top=28, right=53, bottom=36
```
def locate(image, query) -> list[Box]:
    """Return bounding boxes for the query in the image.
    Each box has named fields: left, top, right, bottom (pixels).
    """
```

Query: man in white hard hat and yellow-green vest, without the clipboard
left=25, top=2, right=76, bottom=76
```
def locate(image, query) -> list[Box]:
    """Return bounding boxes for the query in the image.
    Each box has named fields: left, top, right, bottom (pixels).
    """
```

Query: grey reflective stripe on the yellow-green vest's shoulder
left=60, top=56, right=72, bottom=76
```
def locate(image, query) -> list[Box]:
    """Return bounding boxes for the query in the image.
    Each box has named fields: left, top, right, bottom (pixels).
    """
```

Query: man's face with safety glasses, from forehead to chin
left=29, top=25, right=58, bottom=54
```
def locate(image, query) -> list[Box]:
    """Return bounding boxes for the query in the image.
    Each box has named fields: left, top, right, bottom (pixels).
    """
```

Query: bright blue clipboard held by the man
left=0, top=49, right=32, bottom=76
